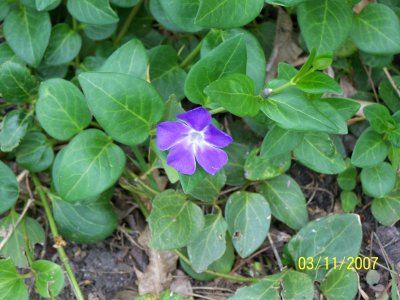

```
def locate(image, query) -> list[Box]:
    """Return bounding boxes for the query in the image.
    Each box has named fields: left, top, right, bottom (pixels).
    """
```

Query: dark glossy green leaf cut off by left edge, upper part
left=0, top=61, right=38, bottom=103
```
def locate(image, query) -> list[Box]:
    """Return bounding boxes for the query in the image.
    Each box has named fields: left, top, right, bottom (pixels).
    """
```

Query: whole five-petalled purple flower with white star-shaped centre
left=157, top=107, right=232, bottom=175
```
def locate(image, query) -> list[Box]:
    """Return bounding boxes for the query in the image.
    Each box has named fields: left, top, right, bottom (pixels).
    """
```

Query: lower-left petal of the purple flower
left=167, top=141, right=196, bottom=175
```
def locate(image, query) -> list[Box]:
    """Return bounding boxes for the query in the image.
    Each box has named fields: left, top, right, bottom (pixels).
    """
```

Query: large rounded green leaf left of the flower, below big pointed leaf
left=53, top=129, right=125, bottom=202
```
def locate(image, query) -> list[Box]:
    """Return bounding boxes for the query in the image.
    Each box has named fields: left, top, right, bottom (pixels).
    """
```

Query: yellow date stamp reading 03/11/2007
left=297, top=256, right=378, bottom=271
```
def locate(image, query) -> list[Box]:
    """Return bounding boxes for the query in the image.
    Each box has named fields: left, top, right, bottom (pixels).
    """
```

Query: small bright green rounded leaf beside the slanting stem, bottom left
left=31, top=260, right=64, bottom=298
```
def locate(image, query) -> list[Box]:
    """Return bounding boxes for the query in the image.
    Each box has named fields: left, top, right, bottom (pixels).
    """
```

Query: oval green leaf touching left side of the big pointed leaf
left=36, top=79, right=91, bottom=140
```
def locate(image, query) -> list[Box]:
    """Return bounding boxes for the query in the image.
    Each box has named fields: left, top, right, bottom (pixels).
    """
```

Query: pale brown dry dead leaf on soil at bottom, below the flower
left=135, top=227, right=178, bottom=295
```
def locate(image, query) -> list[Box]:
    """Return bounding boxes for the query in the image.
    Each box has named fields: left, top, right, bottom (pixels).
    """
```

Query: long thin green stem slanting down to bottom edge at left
left=32, top=174, right=85, bottom=300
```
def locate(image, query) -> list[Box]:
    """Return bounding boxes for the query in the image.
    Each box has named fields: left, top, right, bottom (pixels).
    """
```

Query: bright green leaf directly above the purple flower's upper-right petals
left=204, top=74, right=262, bottom=117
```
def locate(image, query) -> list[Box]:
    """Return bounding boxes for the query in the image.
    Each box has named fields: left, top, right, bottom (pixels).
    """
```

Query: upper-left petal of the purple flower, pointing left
left=156, top=122, right=191, bottom=151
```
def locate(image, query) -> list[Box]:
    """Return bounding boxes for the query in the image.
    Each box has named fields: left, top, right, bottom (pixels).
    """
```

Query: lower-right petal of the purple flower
left=196, top=144, right=228, bottom=175
